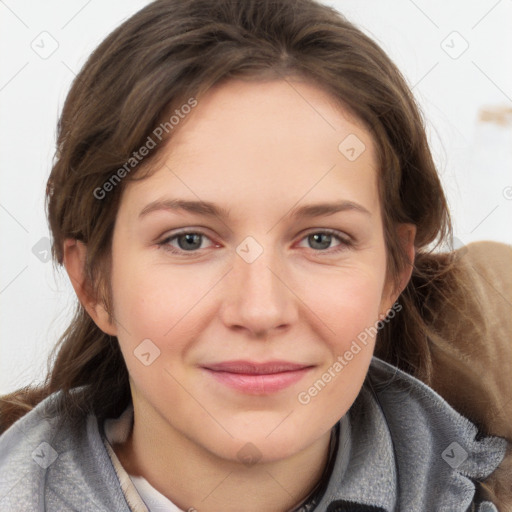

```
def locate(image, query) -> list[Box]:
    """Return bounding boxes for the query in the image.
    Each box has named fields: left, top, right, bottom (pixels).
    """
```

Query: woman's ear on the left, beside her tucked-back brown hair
left=64, top=238, right=117, bottom=336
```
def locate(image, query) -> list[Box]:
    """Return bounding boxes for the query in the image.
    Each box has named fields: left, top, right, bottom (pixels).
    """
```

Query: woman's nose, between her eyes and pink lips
left=221, top=245, right=298, bottom=339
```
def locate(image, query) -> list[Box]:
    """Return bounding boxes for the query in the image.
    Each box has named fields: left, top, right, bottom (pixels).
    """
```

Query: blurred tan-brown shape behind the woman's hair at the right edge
left=429, top=241, right=512, bottom=441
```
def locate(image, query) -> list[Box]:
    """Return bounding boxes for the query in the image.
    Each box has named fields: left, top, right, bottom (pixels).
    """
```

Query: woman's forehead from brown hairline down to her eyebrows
left=118, top=80, right=377, bottom=219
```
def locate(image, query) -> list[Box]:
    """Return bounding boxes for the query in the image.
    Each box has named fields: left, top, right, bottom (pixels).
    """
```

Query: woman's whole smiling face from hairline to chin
left=105, top=80, right=412, bottom=461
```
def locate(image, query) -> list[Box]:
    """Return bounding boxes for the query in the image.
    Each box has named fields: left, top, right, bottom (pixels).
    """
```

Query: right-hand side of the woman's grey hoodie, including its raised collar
left=318, top=357, right=506, bottom=512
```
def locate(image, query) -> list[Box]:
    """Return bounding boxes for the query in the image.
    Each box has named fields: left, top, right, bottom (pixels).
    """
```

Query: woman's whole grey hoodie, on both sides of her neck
left=0, top=358, right=507, bottom=512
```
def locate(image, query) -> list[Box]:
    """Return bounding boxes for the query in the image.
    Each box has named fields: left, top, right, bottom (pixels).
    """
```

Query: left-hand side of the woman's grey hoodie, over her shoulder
left=0, top=392, right=129, bottom=512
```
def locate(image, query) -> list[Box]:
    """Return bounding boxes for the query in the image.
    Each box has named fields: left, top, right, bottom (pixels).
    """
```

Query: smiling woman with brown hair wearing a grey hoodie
left=0, top=0, right=506, bottom=511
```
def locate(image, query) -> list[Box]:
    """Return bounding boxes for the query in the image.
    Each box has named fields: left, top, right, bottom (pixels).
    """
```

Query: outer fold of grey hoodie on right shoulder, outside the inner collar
left=362, top=358, right=507, bottom=510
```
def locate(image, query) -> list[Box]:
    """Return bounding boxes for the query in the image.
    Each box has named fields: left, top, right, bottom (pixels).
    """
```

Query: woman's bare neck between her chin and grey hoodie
left=114, top=402, right=331, bottom=512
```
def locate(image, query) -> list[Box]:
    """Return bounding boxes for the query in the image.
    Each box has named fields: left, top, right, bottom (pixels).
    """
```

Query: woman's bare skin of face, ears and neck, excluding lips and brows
left=65, top=80, right=415, bottom=512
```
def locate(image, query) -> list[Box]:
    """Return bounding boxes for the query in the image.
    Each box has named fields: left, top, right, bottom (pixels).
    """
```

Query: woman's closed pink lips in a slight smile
left=202, top=361, right=313, bottom=395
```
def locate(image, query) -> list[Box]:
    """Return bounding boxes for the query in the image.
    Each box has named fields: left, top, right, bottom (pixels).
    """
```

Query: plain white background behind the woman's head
left=0, top=0, right=512, bottom=394
